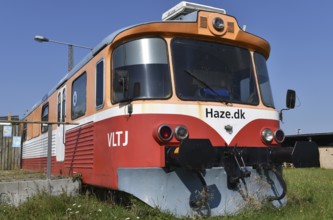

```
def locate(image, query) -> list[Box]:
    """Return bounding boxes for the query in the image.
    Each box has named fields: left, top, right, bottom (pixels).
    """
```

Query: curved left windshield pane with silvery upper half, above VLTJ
left=112, top=38, right=172, bottom=102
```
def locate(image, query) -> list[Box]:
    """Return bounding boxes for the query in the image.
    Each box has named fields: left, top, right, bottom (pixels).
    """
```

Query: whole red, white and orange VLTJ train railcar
left=22, top=2, right=318, bottom=216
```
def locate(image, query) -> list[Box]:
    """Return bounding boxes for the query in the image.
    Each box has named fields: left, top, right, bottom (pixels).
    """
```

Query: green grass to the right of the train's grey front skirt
left=219, top=168, right=333, bottom=220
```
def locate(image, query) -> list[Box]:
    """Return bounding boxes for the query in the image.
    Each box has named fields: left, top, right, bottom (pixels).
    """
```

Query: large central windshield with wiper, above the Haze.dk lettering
left=171, top=39, right=269, bottom=105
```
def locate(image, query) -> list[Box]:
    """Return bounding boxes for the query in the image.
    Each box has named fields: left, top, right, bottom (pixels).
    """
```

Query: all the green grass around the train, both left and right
left=0, top=169, right=333, bottom=220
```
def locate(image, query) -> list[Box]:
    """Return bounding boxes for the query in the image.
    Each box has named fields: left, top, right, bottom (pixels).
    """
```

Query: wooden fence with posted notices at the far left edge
left=0, top=116, right=21, bottom=170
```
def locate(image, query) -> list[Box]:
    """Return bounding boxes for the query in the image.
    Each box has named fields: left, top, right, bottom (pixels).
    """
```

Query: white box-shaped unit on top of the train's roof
left=162, top=1, right=227, bottom=21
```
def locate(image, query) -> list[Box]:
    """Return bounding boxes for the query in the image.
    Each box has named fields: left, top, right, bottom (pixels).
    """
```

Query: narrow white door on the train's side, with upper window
left=56, top=86, right=66, bottom=162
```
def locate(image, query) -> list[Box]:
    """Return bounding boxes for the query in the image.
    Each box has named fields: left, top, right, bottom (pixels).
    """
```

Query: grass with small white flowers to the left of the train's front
left=0, top=190, right=173, bottom=220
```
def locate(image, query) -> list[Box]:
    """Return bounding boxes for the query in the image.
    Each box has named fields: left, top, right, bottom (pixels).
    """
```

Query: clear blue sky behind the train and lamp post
left=0, top=0, right=333, bottom=134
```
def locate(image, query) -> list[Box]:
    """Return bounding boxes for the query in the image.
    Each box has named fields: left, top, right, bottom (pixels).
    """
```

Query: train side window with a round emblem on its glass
left=71, top=72, right=87, bottom=120
